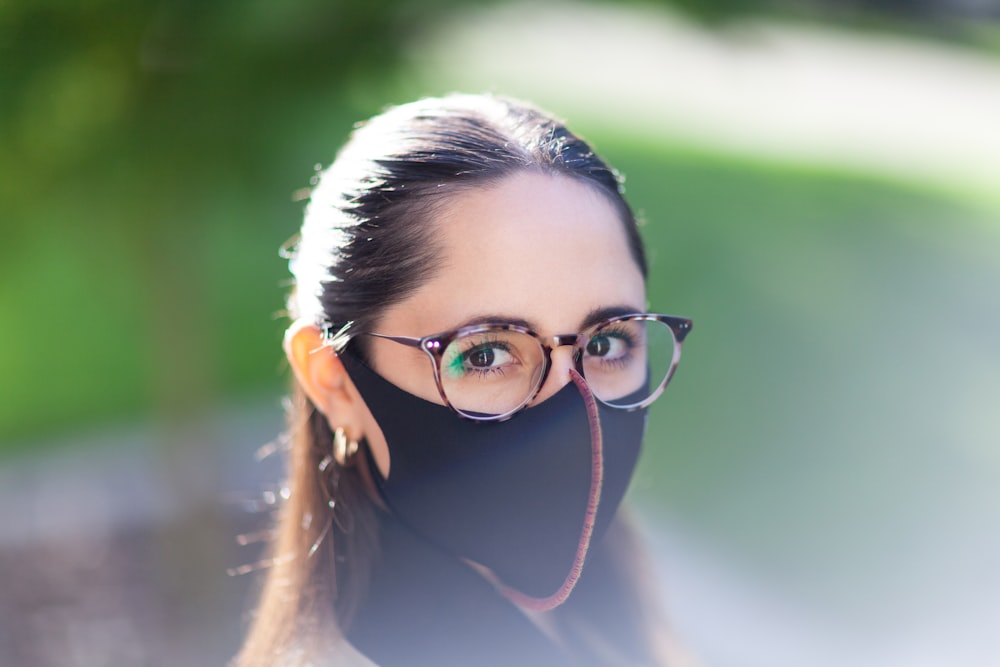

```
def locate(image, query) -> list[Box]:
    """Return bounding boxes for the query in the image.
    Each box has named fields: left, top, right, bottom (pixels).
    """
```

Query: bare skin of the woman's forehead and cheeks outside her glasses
left=362, top=171, right=646, bottom=477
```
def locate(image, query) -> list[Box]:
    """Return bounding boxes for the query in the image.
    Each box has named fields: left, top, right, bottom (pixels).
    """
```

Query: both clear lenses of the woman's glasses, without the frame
left=440, top=320, right=674, bottom=416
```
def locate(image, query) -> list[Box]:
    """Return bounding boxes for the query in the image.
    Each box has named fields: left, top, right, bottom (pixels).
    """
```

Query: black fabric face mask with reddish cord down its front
left=340, top=351, right=646, bottom=610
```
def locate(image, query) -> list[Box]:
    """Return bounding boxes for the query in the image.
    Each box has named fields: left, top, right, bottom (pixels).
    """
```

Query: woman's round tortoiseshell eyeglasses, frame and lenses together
left=354, top=313, right=692, bottom=421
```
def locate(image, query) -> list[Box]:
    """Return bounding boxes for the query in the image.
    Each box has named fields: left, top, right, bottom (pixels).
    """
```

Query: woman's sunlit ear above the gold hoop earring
left=284, top=320, right=367, bottom=440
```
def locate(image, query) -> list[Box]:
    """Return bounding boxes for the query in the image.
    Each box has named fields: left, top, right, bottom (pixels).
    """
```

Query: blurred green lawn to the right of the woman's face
left=612, top=136, right=1000, bottom=604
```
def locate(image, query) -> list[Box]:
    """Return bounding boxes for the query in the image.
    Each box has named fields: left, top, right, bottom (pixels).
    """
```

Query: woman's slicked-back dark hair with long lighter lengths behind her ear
left=230, top=95, right=660, bottom=667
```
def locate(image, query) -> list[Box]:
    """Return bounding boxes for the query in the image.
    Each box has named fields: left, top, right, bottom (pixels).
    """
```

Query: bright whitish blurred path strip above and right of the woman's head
left=413, top=3, right=1000, bottom=201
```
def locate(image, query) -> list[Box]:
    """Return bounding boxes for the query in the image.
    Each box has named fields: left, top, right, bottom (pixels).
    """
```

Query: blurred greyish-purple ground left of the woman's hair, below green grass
left=0, top=401, right=282, bottom=667
